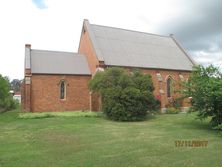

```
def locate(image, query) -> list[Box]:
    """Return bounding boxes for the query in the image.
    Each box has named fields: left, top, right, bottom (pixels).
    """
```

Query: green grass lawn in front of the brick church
left=0, top=111, right=222, bottom=167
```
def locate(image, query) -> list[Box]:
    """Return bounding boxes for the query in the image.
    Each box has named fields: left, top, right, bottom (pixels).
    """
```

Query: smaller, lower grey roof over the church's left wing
left=31, top=49, right=90, bottom=75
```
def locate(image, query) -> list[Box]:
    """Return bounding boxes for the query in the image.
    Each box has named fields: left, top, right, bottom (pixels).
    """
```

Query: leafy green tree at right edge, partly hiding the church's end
left=184, top=65, right=222, bottom=129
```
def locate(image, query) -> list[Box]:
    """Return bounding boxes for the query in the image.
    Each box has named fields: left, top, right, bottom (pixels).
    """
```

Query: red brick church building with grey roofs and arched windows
left=22, top=20, right=195, bottom=112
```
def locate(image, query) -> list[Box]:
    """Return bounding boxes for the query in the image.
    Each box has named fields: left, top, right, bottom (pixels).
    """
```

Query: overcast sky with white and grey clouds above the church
left=0, top=0, right=222, bottom=79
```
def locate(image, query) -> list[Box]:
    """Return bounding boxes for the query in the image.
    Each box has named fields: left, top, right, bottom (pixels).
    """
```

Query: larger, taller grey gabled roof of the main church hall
left=84, top=20, right=195, bottom=71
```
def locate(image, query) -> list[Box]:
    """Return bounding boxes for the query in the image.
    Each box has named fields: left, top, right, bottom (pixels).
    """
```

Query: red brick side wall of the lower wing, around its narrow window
left=31, top=74, right=91, bottom=112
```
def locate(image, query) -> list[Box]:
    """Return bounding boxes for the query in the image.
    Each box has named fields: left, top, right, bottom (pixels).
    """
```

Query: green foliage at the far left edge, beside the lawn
left=0, top=75, right=18, bottom=112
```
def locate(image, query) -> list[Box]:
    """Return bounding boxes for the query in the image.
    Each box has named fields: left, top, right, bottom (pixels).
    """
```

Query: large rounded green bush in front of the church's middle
left=89, top=67, right=159, bottom=121
